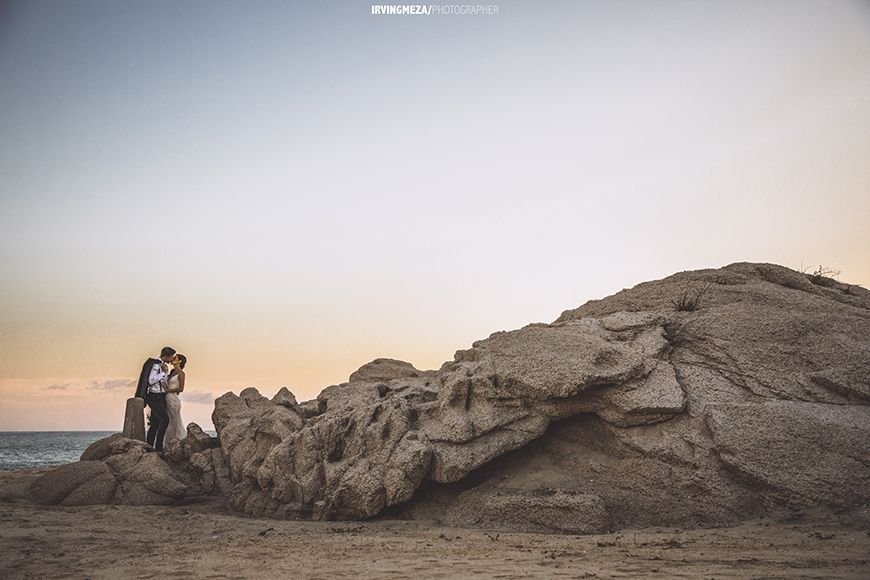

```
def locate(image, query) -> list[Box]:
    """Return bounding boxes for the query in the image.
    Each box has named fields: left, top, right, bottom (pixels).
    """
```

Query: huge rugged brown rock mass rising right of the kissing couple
left=25, top=264, right=870, bottom=532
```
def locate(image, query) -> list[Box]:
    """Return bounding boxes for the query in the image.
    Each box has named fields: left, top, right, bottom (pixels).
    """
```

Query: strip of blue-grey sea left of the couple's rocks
left=0, top=431, right=121, bottom=471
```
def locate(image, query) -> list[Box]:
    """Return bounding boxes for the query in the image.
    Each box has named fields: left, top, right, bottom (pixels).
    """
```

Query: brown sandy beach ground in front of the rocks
left=0, top=472, right=870, bottom=579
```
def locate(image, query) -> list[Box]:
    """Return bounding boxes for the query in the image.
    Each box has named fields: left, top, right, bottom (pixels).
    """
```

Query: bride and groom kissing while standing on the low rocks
left=136, top=346, right=187, bottom=451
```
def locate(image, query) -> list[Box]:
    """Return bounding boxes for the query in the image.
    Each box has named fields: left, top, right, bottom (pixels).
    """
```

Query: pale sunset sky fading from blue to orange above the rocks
left=0, top=0, right=870, bottom=430
